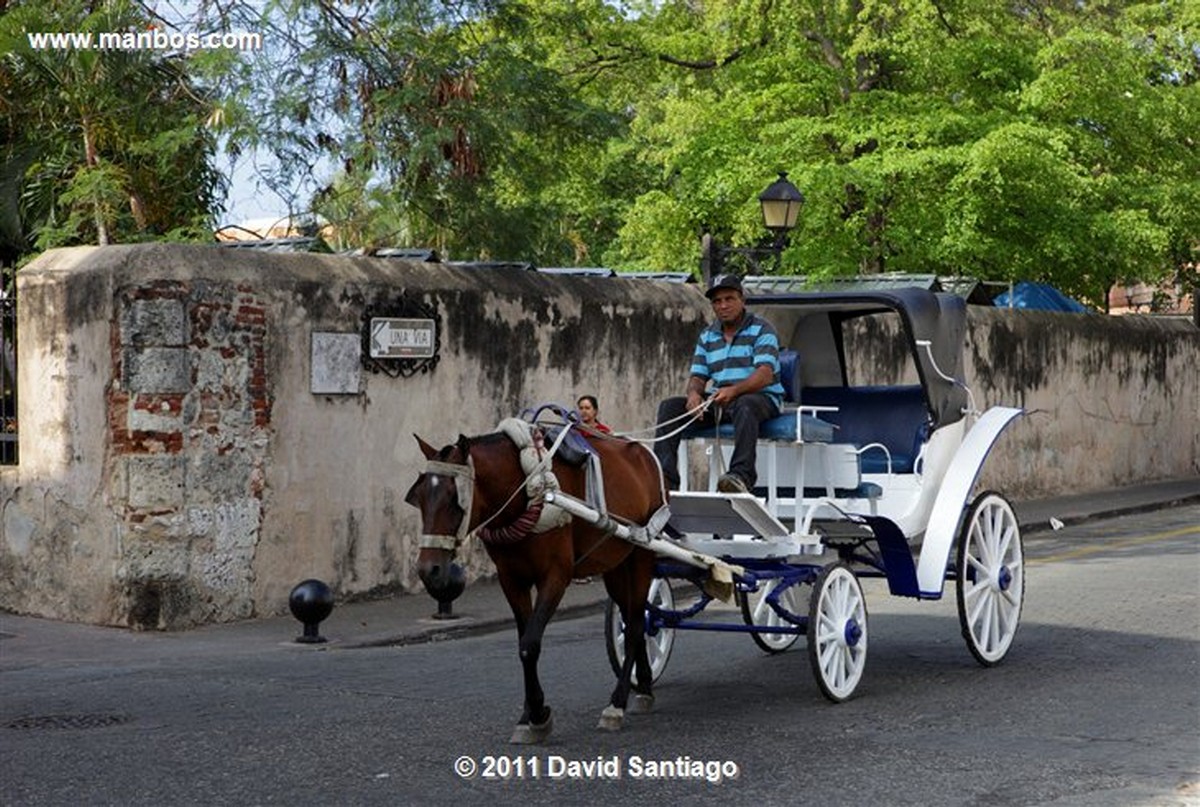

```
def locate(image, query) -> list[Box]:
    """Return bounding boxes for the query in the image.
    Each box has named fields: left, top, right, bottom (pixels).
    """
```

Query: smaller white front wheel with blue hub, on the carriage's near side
left=809, top=562, right=866, bottom=704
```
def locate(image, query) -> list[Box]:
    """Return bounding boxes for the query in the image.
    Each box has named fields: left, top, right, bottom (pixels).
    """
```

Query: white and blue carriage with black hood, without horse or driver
left=549, top=288, right=1025, bottom=701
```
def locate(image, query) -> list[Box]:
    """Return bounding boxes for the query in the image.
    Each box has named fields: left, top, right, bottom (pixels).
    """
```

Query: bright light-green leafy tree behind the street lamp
left=611, top=0, right=1200, bottom=301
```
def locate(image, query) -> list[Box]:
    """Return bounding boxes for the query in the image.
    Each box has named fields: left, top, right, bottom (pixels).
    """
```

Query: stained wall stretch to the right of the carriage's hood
left=965, top=306, right=1200, bottom=497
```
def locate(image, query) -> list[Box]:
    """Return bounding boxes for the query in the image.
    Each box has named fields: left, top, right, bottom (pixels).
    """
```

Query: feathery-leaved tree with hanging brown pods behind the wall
left=196, top=0, right=636, bottom=263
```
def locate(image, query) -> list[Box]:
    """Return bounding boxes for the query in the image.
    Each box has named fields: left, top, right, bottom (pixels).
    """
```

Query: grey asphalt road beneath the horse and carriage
left=0, top=506, right=1200, bottom=807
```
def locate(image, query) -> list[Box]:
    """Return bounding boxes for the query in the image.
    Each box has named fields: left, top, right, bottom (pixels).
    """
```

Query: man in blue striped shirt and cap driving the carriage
left=654, top=275, right=784, bottom=494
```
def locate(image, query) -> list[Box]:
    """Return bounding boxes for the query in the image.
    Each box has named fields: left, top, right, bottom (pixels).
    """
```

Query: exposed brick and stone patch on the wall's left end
left=107, top=281, right=274, bottom=627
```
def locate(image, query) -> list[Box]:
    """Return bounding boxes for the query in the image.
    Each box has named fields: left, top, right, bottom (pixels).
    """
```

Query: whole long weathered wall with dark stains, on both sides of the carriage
left=0, top=245, right=1200, bottom=628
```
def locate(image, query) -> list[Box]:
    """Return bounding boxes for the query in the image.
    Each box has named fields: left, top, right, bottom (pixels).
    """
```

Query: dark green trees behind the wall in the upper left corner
left=0, top=0, right=221, bottom=273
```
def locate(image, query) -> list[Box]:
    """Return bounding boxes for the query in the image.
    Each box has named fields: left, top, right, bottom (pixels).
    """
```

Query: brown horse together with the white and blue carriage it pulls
left=409, top=288, right=1025, bottom=742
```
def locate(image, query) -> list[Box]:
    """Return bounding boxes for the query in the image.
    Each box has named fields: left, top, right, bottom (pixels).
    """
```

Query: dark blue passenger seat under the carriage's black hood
left=804, top=384, right=929, bottom=473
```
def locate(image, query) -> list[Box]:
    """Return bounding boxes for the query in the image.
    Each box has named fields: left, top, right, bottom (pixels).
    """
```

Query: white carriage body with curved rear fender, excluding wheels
left=671, top=289, right=1021, bottom=598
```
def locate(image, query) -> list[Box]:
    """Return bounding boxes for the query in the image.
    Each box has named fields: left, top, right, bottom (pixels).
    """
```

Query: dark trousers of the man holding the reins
left=654, top=393, right=779, bottom=490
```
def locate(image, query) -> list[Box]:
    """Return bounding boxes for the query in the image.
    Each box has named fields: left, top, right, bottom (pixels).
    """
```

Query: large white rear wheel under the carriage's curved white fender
left=955, top=491, right=1025, bottom=666
